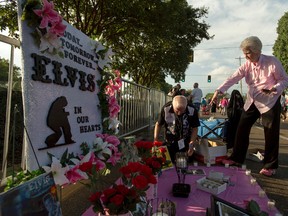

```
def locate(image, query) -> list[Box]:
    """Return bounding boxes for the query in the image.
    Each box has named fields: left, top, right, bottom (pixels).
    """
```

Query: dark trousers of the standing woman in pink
left=230, top=99, right=281, bottom=169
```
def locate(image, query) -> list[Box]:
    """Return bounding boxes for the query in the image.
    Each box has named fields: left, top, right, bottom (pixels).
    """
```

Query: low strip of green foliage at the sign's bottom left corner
left=4, top=169, right=45, bottom=191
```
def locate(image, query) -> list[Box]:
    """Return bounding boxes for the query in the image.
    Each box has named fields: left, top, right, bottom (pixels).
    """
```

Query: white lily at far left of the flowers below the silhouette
left=43, top=157, right=69, bottom=186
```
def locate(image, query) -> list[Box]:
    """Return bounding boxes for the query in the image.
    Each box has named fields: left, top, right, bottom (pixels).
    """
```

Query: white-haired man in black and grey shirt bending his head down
left=154, top=95, right=200, bottom=162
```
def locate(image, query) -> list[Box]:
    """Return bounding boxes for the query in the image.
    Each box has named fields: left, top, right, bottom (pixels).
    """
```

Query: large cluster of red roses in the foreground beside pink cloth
left=89, top=162, right=157, bottom=215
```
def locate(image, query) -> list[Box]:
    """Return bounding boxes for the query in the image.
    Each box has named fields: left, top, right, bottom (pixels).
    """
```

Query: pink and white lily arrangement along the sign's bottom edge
left=43, top=134, right=121, bottom=188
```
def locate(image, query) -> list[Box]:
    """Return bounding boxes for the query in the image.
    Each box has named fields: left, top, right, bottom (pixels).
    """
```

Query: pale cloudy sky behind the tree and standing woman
left=0, top=0, right=288, bottom=96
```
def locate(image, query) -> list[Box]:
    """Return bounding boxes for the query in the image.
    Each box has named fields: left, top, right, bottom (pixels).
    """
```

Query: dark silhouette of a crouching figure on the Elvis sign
left=45, top=96, right=75, bottom=147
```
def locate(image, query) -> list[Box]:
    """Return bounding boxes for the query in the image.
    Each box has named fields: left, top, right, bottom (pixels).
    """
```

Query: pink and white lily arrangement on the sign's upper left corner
left=22, top=0, right=66, bottom=57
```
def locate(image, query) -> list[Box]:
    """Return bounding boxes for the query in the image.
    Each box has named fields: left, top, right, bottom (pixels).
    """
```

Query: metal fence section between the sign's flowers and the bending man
left=118, top=79, right=171, bottom=137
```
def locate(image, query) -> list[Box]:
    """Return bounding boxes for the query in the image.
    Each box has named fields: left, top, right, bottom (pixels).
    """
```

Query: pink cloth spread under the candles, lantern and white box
left=158, top=166, right=278, bottom=216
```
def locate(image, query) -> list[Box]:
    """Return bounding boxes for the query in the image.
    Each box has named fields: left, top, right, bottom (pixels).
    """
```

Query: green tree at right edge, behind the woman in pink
left=273, top=12, right=288, bottom=73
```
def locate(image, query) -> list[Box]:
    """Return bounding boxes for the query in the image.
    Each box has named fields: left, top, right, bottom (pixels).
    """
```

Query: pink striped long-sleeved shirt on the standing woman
left=217, top=54, right=288, bottom=113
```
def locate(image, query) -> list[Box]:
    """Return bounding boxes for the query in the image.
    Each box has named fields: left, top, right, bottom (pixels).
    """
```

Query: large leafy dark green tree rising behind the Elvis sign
left=0, top=0, right=212, bottom=87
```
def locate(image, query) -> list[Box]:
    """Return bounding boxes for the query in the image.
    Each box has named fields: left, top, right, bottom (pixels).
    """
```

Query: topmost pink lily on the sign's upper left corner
left=34, top=0, right=59, bottom=28
